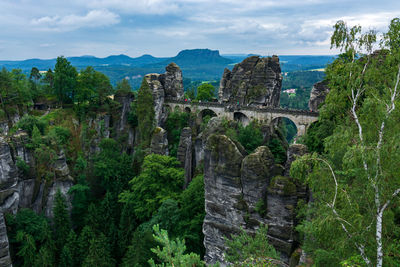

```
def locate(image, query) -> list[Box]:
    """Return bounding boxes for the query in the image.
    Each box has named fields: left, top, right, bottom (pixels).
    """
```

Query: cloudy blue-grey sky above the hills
left=0, top=0, right=400, bottom=60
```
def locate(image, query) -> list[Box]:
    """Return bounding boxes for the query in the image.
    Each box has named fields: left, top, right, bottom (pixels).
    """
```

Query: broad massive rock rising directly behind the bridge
left=219, top=56, right=282, bottom=107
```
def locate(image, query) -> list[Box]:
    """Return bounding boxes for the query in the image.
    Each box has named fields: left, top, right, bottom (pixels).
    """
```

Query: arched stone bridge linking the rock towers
left=164, top=98, right=318, bottom=136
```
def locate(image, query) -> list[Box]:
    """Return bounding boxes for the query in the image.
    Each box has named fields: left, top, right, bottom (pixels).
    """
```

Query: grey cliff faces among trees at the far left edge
left=0, top=135, right=73, bottom=217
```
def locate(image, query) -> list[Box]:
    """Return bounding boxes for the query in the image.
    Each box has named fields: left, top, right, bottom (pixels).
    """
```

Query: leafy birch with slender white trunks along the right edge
left=291, top=19, right=400, bottom=266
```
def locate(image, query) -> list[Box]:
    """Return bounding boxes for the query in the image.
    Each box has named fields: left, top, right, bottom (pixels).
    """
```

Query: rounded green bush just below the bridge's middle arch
left=238, top=121, right=263, bottom=153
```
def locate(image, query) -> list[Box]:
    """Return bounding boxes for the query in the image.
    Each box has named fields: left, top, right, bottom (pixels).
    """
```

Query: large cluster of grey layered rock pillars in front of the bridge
left=203, top=134, right=303, bottom=264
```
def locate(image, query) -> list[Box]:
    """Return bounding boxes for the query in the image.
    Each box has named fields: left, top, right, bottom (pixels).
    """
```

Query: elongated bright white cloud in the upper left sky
left=31, top=9, right=120, bottom=31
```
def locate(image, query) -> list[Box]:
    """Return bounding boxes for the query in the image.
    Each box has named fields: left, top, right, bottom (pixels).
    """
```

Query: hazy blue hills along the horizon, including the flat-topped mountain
left=0, top=49, right=334, bottom=88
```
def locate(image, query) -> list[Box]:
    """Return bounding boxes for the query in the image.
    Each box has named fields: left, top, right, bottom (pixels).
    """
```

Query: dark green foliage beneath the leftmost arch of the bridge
left=165, top=111, right=190, bottom=157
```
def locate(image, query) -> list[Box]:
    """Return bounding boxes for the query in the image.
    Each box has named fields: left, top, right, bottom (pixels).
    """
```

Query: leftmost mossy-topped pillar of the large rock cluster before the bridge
left=203, top=135, right=245, bottom=263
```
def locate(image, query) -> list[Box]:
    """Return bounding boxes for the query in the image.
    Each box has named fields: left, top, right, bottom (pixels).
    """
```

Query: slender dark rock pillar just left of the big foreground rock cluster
left=177, top=127, right=193, bottom=188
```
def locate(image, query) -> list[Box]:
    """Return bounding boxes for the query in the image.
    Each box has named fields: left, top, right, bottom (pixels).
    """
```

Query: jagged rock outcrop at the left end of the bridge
left=145, top=63, right=183, bottom=127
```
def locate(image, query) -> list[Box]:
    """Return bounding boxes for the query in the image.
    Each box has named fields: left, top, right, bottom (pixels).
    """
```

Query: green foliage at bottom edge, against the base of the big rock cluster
left=225, top=225, right=279, bottom=266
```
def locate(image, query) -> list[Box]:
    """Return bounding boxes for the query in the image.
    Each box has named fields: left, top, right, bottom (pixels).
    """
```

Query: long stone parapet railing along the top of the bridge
left=164, top=98, right=319, bottom=117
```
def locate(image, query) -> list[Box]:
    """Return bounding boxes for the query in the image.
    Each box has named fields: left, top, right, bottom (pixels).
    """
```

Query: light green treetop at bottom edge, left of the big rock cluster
left=149, top=225, right=205, bottom=267
